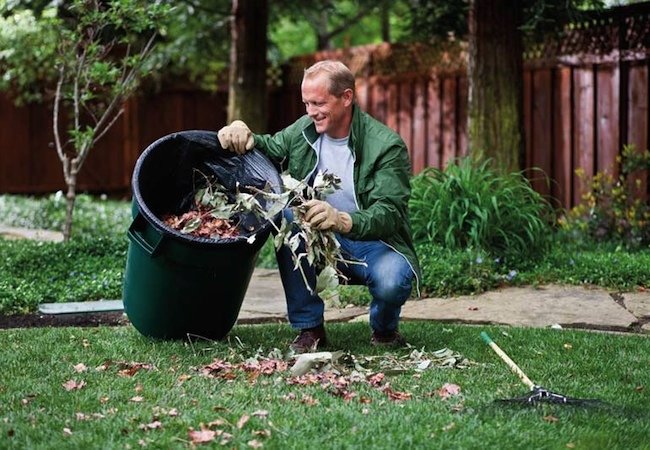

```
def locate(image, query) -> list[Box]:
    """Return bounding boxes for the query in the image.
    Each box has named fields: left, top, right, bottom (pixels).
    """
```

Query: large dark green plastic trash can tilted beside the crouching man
left=123, top=130, right=282, bottom=339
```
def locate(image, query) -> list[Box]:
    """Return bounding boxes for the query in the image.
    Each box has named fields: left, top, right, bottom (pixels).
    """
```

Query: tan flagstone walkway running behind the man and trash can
left=0, top=226, right=650, bottom=333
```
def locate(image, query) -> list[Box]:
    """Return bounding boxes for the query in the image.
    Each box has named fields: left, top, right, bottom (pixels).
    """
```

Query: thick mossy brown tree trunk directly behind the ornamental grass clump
left=468, top=0, right=525, bottom=173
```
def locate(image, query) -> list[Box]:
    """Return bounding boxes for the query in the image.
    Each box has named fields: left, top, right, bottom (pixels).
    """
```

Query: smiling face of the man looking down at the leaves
left=302, top=74, right=352, bottom=138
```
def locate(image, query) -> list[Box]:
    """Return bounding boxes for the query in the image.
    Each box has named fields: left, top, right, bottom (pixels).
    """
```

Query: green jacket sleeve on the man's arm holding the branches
left=347, top=144, right=411, bottom=240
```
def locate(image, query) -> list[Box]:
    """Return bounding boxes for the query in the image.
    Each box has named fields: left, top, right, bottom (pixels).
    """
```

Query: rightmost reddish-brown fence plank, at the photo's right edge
left=627, top=62, right=650, bottom=201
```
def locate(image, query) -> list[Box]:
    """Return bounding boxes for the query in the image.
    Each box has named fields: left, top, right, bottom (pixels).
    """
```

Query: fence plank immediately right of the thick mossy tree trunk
left=530, top=69, right=553, bottom=196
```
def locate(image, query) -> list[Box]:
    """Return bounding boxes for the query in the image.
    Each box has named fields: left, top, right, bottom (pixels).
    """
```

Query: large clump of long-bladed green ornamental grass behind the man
left=409, top=158, right=554, bottom=266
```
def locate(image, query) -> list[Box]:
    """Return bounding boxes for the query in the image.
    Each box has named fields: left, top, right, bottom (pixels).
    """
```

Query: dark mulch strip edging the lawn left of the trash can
left=0, top=312, right=129, bottom=329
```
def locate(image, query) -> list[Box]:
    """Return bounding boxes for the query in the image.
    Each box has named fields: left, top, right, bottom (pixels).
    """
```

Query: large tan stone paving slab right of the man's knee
left=402, top=285, right=638, bottom=330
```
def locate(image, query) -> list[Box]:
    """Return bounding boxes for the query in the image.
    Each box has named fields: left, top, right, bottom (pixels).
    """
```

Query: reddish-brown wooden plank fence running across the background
left=0, top=4, right=650, bottom=211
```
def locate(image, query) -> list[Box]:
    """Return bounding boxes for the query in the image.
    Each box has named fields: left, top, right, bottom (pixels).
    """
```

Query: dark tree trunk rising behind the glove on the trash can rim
left=228, top=0, right=269, bottom=133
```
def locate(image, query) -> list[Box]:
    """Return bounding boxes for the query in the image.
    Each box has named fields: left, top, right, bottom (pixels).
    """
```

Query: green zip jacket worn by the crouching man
left=255, top=105, right=421, bottom=295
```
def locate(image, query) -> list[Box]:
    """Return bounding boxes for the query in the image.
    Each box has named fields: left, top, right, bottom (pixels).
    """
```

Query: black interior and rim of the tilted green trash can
left=133, top=130, right=282, bottom=243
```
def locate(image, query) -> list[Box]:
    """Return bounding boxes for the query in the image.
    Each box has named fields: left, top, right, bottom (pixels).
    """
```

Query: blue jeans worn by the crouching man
left=276, top=210, right=414, bottom=333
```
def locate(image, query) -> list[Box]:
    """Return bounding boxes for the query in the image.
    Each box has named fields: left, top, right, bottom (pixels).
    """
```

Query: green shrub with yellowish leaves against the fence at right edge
left=560, top=146, right=650, bottom=249
